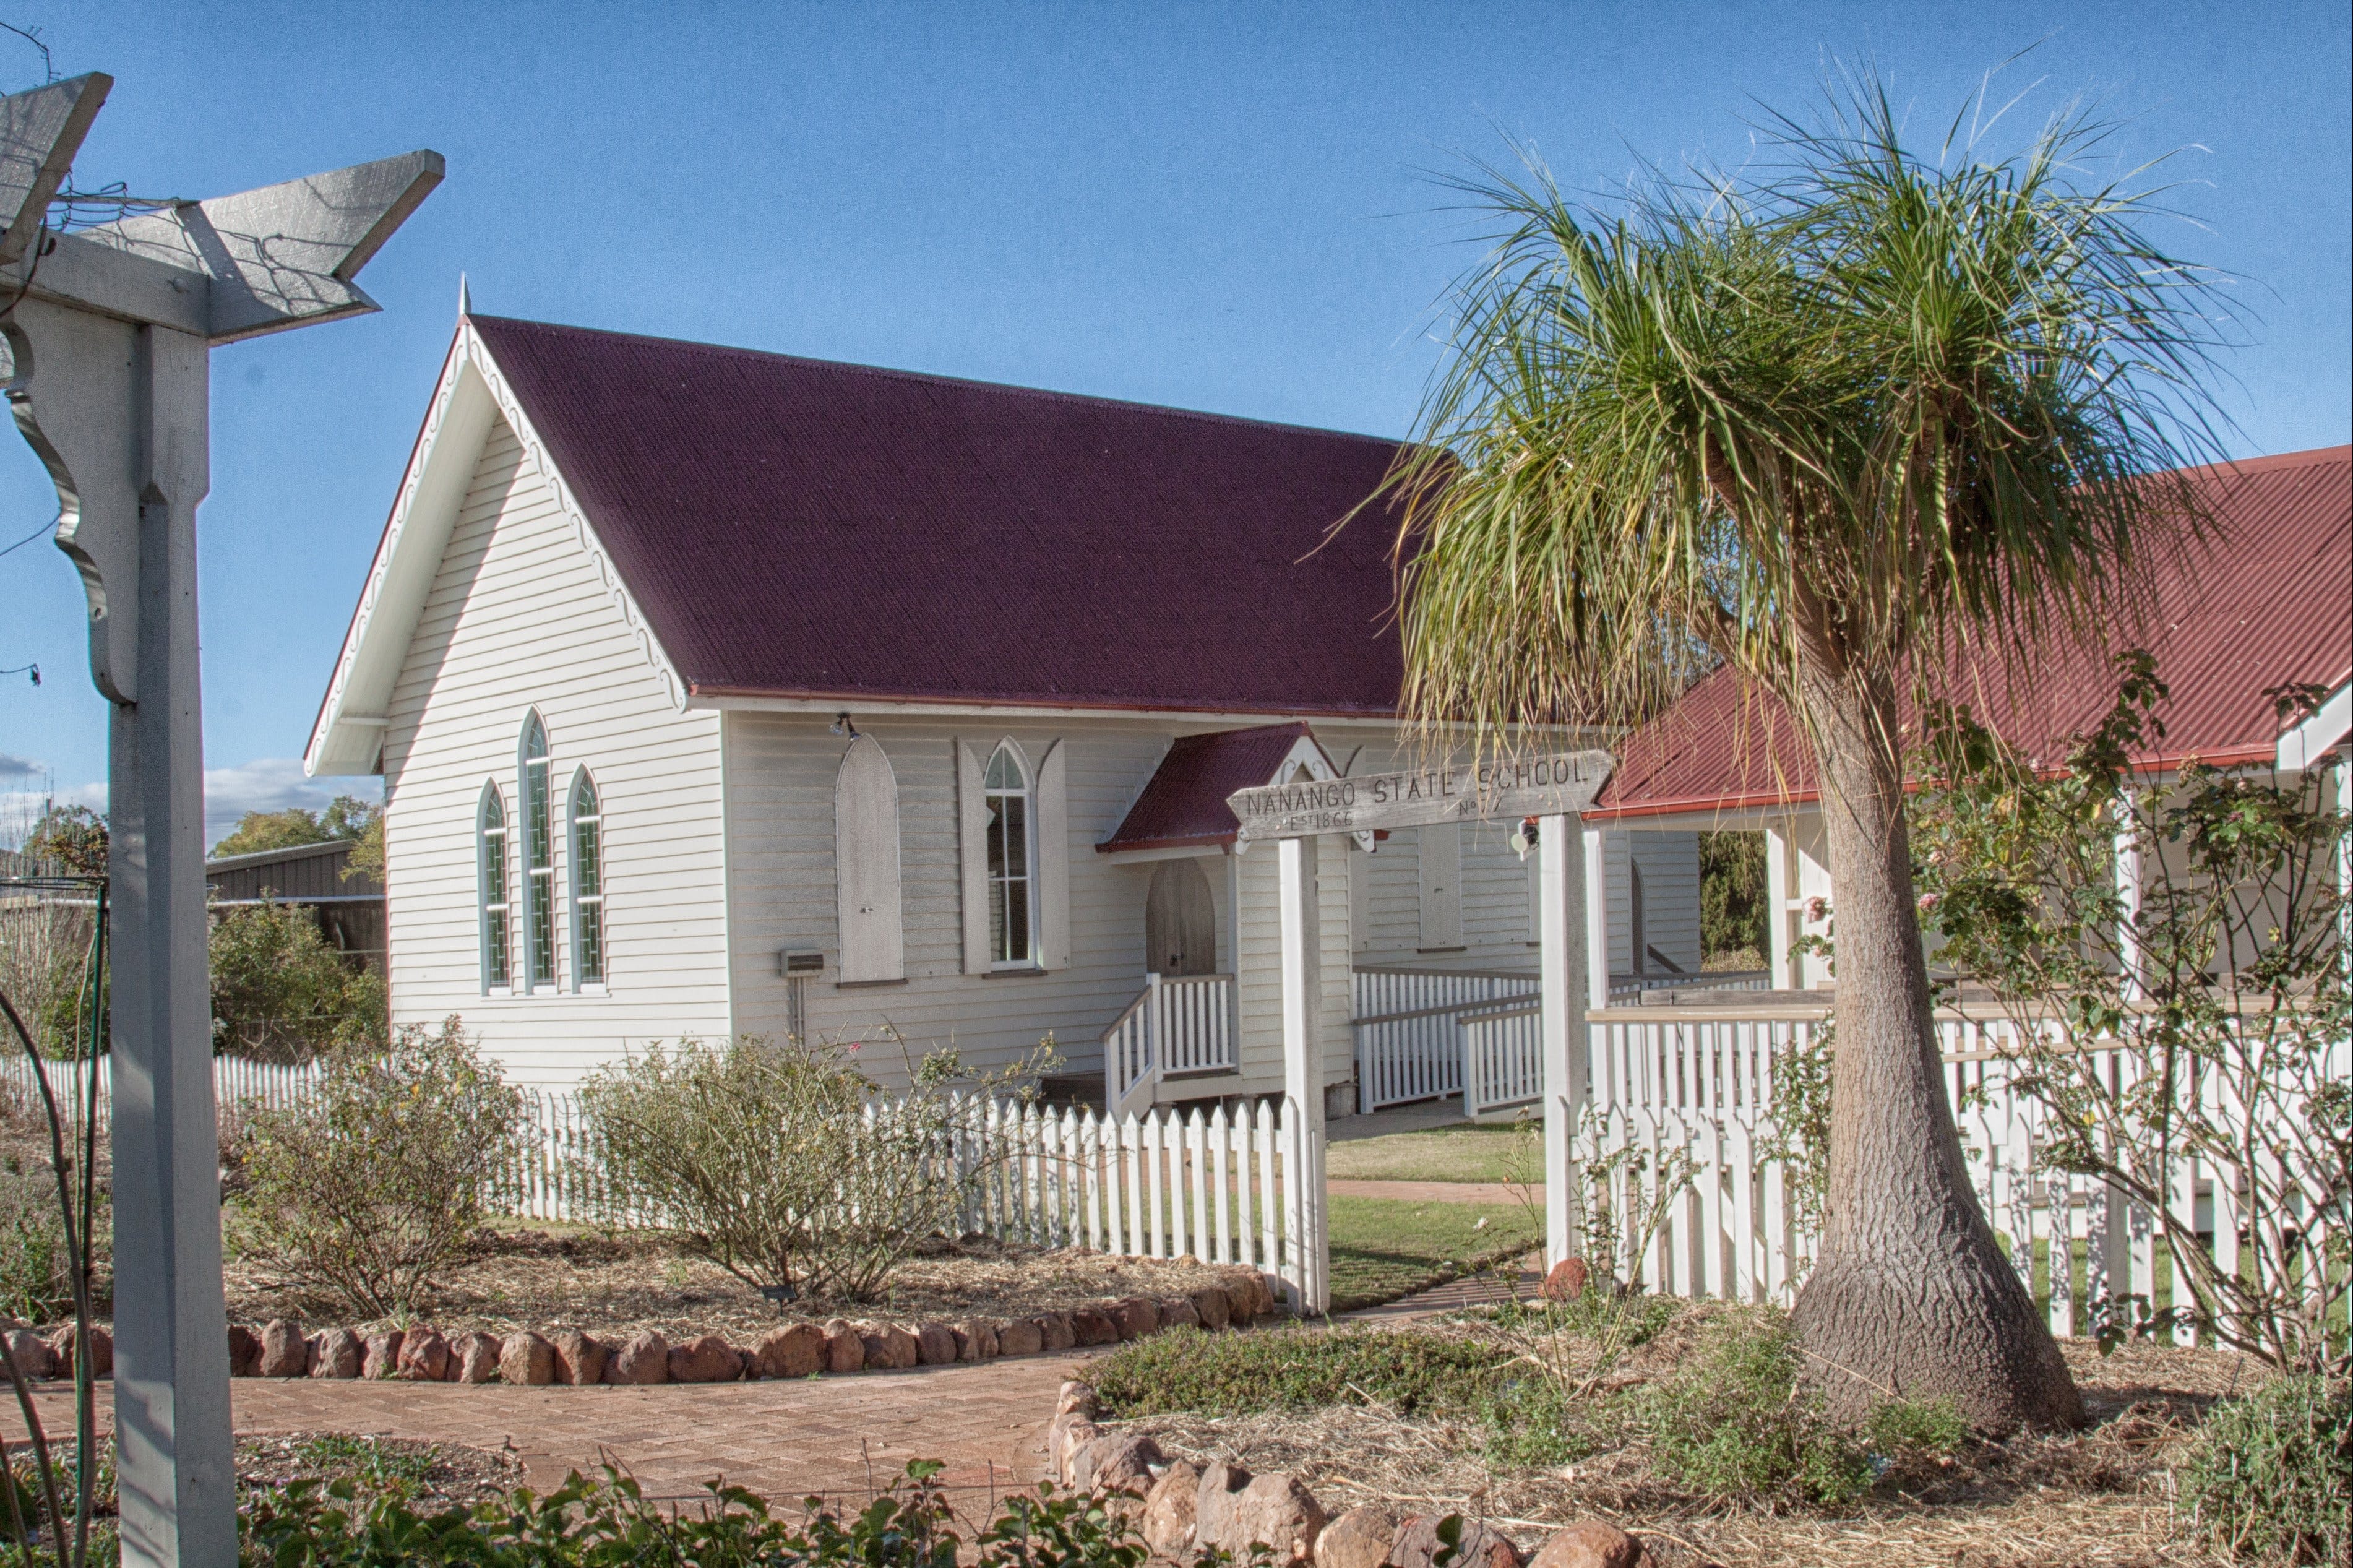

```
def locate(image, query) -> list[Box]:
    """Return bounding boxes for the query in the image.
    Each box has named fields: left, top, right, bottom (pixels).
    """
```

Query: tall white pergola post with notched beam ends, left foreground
left=0, top=73, right=442, bottom=1568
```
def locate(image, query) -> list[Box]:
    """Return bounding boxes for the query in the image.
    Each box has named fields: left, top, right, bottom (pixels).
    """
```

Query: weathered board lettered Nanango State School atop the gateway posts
left=1226, top=751, right=1612, bottom=840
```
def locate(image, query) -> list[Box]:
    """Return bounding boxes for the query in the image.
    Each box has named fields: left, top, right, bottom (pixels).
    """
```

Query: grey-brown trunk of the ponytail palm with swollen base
left=1796, top=659, right=2083, bottom=1434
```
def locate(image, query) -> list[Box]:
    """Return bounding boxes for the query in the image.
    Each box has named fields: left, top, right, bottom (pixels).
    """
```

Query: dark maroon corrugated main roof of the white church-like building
left=473, top=316, right=1403, bottom=713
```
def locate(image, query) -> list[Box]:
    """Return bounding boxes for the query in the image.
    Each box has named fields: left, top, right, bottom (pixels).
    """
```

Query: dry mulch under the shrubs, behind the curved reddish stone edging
left=226, top=1226, right=1224, bottom=1340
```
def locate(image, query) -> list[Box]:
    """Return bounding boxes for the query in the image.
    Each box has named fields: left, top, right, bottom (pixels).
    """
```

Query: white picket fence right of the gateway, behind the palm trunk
left=1579, top=1017, right=2348, bottom=1345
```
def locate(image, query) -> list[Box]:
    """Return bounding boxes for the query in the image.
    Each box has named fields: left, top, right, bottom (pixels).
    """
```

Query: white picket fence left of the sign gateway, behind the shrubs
left=0, top=1057, right=1320, bottom=1304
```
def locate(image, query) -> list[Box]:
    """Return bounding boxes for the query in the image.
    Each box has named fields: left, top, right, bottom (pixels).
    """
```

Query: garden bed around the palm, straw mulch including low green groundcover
left=1094, top=1307, right=2261, bottom=1568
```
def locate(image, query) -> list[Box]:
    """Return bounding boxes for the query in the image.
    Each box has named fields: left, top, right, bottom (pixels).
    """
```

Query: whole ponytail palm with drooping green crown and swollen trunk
left=1388, top=82, right=2214, bottom=1431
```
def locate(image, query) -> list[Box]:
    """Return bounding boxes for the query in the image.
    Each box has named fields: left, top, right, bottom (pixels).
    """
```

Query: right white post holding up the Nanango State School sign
left=1536, top=814, right=1609, bottom=1269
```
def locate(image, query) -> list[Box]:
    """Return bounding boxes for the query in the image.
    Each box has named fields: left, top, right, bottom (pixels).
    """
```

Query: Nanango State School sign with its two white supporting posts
left=1226, top=751, right=1614, bottom=1314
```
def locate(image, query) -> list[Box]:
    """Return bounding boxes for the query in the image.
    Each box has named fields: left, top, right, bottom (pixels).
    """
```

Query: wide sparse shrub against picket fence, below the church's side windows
left=581, top=1038, right=1028, bottom=1299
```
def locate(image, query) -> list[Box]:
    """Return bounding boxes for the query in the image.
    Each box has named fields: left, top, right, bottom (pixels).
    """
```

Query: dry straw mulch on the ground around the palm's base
left=1111, top=1323, right=2256, bottom=1568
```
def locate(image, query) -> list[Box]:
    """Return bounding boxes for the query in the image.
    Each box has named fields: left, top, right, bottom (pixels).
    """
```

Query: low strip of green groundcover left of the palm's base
left=1090, top=1325, right=1506, bottom=1417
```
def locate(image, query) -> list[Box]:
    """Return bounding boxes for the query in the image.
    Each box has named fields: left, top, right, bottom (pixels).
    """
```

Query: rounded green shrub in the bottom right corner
left=2174, top=1375, right=2353, bottom=1563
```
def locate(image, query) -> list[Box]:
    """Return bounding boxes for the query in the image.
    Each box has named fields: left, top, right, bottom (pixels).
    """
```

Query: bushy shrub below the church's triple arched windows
left=238, top=1017, right=522, bottom=1316
